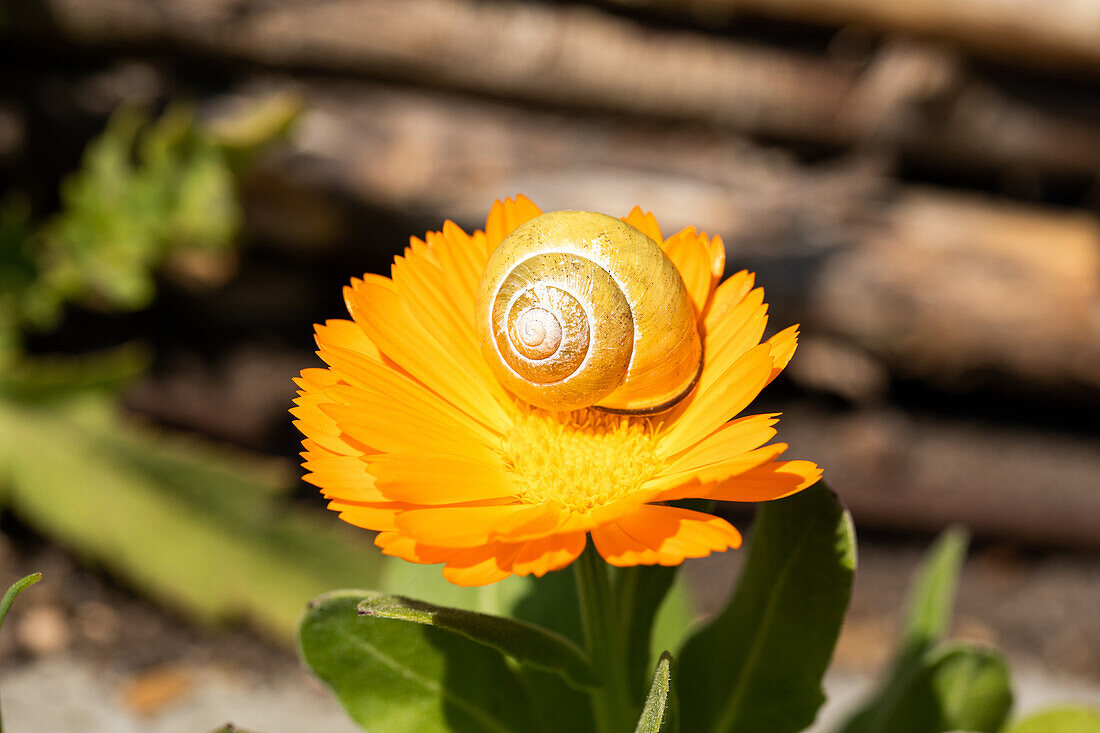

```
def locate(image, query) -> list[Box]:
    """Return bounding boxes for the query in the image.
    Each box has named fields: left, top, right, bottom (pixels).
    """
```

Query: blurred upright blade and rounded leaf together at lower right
left=842, top=521, right=1012, bottom=733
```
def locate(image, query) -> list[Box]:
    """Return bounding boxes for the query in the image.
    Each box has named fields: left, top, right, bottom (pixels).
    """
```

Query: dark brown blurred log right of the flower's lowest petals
left=780, top=405, right=1100, bottom=550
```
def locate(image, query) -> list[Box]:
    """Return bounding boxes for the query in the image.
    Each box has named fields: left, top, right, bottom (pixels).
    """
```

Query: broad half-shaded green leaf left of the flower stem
left=298, top=591, right=537, bottom=733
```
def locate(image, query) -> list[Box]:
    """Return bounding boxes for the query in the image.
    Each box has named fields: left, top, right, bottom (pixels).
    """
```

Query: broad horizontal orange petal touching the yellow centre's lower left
left=367, top=452, right=515, bottom=504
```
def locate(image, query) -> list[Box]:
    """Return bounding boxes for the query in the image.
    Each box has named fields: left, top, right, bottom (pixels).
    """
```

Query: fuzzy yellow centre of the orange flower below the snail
left=504, top=409, right=662, bottom=514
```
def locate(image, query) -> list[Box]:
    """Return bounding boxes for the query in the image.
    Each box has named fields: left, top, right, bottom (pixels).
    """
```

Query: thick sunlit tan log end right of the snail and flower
left=807, top=189, right=1100, bottom=398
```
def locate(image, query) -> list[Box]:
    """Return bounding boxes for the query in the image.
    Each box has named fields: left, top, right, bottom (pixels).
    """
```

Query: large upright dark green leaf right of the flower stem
left=677, top=482, right=856, bottom=733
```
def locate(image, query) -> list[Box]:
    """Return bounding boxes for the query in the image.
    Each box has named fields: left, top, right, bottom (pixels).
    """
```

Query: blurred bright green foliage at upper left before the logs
left=0, top=96, right=300, bottom=353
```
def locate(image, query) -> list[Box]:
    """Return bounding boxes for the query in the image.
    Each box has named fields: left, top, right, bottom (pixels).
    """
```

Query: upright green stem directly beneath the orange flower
left=573, top=547, right=637, bottom=733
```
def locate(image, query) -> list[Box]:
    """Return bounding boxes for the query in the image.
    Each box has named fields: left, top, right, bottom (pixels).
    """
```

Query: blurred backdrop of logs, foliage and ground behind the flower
left=0, top=0, right=1100, bottom=733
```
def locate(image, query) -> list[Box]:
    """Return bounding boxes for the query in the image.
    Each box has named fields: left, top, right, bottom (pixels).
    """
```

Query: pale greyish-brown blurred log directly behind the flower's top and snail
left=238, top=83, right=866, bottom=252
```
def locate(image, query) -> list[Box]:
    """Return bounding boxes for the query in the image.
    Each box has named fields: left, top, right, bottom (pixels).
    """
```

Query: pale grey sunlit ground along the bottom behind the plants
left=0, top=654, right=1100, bottom=733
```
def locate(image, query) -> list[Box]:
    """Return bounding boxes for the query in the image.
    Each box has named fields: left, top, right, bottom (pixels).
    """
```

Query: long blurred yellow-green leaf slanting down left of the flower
left=0, top=391, right=381, bottom=638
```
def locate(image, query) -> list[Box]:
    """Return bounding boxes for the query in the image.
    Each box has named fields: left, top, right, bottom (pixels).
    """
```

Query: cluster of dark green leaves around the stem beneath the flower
left=299, top=484, right=856, bottom=733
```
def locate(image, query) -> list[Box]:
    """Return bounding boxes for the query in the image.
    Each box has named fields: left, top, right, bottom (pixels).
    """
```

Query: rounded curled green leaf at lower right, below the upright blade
left=849, top=644, right=1012, bottom=733
